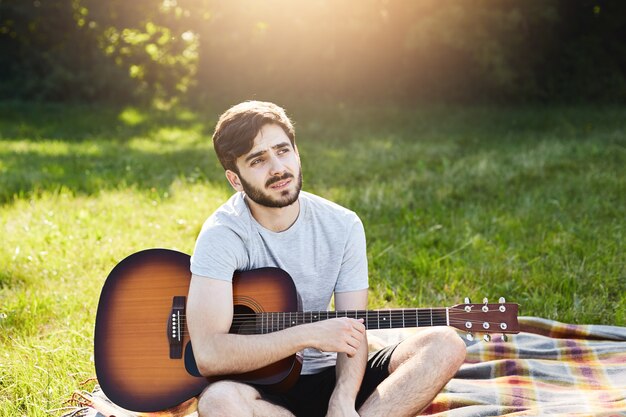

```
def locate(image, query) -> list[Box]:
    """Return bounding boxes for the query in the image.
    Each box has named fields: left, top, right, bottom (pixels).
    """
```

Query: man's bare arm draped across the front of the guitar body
left=187, top=275, right=367, bottom=376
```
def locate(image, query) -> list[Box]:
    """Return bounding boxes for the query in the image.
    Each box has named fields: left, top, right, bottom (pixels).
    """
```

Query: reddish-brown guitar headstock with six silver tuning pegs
left=448, top=297, right=520, bottom=341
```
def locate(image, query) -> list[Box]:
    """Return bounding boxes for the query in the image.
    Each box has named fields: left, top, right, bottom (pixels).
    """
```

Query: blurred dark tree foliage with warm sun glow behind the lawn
left=0, top=0, right=626, bottom=103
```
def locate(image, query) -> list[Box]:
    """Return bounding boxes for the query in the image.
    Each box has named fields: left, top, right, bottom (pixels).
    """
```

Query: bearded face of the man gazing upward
left=226, top=124, right=302, bottom=208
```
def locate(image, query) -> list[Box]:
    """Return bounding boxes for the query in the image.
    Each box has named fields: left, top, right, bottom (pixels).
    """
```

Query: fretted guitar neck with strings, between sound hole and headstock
left=255, top=307, right=449, bottom=333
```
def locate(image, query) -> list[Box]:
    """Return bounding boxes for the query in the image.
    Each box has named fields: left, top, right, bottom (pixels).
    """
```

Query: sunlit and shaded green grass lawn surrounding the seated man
left=0, top=103, right=626, bottom=417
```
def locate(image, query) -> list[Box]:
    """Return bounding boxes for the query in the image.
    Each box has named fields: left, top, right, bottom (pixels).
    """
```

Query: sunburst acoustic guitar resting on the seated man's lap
left=94, top=249, right=519, bottom=412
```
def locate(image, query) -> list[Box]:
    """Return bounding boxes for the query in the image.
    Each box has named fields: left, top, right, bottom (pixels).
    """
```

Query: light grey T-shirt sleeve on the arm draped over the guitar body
left=190, top=225, right=247, bottom=281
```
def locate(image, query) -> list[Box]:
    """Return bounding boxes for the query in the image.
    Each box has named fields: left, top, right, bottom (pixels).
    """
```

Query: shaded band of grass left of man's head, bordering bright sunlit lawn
left=0, top=144, right=232, bottom=205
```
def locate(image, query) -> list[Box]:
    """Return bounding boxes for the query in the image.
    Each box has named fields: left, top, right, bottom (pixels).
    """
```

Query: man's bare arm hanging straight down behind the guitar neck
left=327, top=289, right=368, bottom=417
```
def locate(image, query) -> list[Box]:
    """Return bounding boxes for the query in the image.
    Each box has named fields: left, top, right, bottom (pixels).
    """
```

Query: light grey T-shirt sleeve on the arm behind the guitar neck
left=335, top=217, right=369, bottom=292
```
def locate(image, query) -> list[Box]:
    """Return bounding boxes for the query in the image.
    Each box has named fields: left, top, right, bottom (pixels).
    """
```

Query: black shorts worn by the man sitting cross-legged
left=255, top=344, right=398, bottom=417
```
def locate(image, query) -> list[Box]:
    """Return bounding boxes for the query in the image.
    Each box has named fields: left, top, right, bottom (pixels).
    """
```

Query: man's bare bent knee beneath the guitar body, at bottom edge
left=198, top=381, right=294, bottom=417
